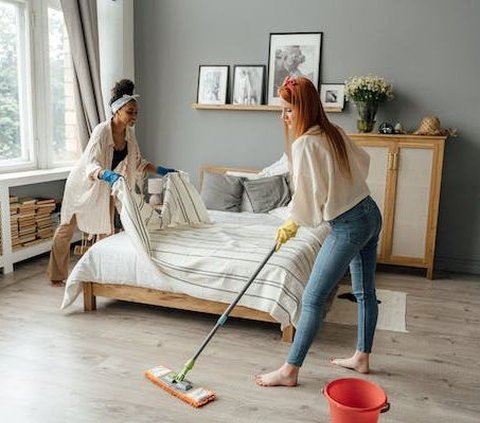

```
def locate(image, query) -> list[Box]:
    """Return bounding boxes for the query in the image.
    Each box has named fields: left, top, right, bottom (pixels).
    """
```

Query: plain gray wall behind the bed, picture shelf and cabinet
left=135, top=0, right=480, bottom=274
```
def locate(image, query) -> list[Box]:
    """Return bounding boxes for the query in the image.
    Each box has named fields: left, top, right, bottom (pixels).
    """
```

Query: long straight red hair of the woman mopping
left=278, top=77, right=351, bottom=176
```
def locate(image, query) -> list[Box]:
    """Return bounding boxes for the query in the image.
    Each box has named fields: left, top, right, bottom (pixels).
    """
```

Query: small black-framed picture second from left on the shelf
left=232, top=65, right=266, bottom=106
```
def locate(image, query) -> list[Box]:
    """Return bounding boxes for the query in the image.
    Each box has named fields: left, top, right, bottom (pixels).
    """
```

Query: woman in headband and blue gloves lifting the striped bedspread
left=47, top=79, right=175, bottom=286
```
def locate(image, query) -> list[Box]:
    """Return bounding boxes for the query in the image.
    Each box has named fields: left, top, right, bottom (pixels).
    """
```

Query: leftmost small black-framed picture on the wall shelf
left=197, top=65, right=230, bottom=104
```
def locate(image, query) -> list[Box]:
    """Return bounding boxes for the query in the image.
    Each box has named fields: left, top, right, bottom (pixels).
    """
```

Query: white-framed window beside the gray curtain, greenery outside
left=0, top=0, right=80, bottom=172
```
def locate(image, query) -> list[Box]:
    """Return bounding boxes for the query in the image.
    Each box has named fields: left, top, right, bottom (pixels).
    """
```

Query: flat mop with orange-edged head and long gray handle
left=145, top=246, right=275, bottom=408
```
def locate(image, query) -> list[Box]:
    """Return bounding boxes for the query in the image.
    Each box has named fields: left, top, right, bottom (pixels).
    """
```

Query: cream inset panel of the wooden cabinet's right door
left=391, top=147, right=433, bottom=261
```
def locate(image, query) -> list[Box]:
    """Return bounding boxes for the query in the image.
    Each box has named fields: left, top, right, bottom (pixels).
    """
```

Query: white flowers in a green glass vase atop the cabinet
left=345, top=75, right=393, bottom=132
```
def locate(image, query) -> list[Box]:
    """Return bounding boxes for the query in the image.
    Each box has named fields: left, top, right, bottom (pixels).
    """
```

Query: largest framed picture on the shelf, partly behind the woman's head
left=267, top=32, right=323, bottom=105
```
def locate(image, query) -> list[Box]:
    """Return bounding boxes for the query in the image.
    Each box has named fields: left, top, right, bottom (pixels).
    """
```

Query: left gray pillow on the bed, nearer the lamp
left=201, top=172, right=243, bottom=212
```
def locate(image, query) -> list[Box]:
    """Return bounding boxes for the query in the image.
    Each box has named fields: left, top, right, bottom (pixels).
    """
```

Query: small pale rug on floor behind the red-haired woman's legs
left=325, top=285, right=408, bottom=333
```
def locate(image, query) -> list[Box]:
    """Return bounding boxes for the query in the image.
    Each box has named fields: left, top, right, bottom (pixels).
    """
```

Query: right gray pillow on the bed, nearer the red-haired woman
left=243, top=174, right=291, bottom=213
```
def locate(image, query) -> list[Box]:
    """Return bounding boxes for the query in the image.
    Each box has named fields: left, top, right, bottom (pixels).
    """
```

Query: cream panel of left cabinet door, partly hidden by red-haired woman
left=363, top=146, right=389, bottom=257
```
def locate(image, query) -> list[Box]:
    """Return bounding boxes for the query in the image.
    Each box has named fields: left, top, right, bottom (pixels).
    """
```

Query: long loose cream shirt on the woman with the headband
left=61, top=119, right=148, bottom=234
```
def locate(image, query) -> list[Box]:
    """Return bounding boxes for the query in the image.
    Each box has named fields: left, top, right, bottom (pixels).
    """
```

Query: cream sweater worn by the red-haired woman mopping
left=290, top=126, right=370, bottom=227
